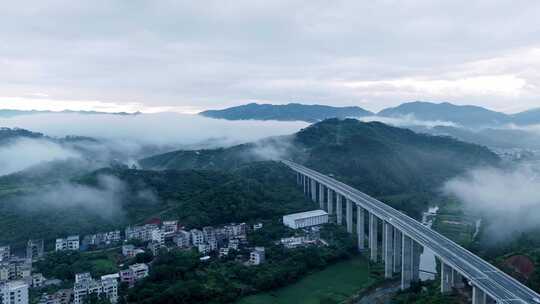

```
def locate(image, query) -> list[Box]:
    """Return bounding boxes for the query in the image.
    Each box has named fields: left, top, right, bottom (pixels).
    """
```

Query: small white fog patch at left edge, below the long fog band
left=0, top=138, right=80, bottom=176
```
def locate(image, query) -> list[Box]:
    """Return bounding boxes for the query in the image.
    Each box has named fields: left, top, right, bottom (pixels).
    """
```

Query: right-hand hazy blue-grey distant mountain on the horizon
left=378, top=101, right=511, bottom=127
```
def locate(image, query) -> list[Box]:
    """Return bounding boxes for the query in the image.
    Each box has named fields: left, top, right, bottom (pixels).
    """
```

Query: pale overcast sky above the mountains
left=0, top=0, right=540, bottom=112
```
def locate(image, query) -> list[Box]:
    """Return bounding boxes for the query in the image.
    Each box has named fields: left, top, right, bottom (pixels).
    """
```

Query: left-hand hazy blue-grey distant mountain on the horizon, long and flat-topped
left=199, top=103, right=373, bottom=122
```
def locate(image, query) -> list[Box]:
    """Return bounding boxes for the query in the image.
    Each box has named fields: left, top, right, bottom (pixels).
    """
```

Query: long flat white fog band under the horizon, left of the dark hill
left=0, top=113, right=307, bottom=148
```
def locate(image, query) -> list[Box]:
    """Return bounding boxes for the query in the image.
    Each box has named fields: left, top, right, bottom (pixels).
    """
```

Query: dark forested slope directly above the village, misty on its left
left=0, top=162, right=313, bottom=247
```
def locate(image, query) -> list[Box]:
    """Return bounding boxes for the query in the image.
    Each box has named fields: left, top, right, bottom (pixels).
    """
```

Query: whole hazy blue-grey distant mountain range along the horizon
left=200, top=101, right=540, bottom=127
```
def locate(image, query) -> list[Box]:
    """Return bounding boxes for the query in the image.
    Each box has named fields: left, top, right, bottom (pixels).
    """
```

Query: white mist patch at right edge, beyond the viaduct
left=444, top=164, right=540, bottom=241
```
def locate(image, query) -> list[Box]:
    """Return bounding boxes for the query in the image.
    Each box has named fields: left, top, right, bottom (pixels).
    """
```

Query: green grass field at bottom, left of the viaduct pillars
left=236, top=257, right=374, bottom=304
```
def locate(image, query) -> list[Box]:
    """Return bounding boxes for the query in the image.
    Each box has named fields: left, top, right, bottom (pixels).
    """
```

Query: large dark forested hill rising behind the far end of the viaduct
left=293, top=120, right=499, bottom=195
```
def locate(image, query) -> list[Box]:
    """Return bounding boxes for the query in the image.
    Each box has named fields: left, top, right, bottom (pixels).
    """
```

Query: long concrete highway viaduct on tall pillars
left=282, top=161, right=540, bottom=304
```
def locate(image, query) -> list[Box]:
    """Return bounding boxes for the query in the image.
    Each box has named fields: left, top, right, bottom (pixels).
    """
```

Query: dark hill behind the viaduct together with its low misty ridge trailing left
left=140, top=119, right=499, bottom=195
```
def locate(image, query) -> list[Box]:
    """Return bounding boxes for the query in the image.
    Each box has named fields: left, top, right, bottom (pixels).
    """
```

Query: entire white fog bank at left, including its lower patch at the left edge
left=0, top=113, right=308, bottom=176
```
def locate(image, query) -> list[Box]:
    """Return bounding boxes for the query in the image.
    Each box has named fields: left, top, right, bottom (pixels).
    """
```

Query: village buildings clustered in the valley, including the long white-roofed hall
left=0, top=211, right=328, bottom=304
